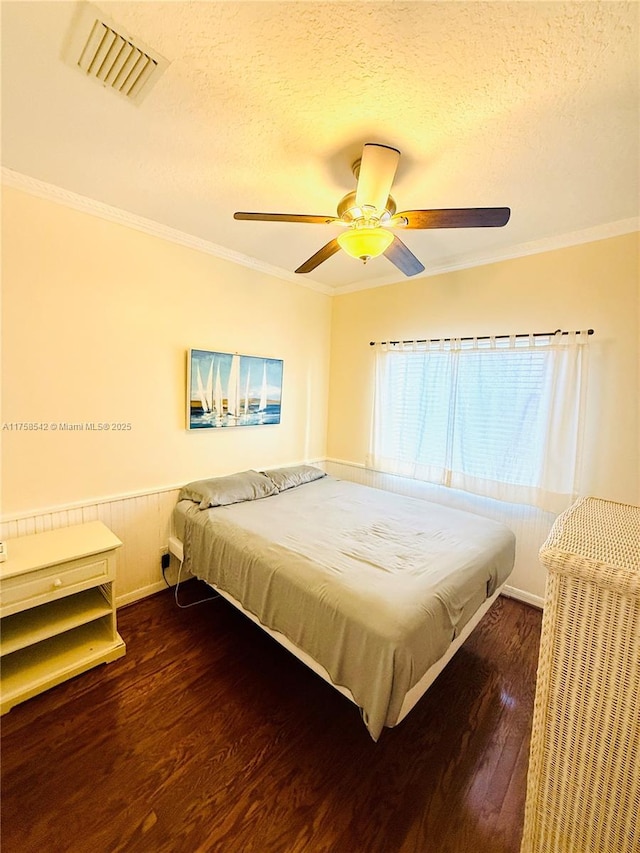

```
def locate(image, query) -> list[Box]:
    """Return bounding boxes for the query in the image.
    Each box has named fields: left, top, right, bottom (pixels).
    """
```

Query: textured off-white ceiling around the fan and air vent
left=1, top=0, right=640, bottom=289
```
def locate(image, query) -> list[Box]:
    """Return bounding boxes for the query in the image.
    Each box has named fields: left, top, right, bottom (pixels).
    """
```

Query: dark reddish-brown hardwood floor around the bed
left=2, top=581, right=541, bottom=853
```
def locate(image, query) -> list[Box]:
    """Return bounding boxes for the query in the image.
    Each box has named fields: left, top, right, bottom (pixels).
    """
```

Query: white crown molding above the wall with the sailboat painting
left=2, top=166, right=334, bottom=296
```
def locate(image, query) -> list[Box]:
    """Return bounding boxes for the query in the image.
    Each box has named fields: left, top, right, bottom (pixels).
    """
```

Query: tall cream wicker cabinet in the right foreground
left=521, top=498, right=640, bottom=853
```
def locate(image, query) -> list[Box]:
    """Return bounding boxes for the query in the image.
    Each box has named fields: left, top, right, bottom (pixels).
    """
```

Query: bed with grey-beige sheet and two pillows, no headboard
left=170, top=466, right=515, bottom=740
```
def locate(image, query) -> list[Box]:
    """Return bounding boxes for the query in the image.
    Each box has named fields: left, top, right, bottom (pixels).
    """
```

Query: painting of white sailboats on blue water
left=187, top=349, right=283, bottom=429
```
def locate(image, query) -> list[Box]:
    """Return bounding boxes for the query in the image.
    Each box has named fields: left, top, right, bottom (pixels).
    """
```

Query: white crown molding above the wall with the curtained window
left=332, top=216, right=640, bottom=296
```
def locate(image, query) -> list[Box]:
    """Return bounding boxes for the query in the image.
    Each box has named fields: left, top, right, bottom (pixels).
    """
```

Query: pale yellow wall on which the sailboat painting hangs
left=0, top=188, right=331, bottom=516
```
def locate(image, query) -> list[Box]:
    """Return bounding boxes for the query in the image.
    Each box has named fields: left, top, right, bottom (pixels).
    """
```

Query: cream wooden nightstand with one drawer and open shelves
left=0, top=521, right=126, bottom=714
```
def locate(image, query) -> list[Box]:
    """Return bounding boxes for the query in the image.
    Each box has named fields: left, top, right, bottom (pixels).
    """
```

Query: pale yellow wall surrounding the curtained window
left=327, top=234, right=640, bottom=503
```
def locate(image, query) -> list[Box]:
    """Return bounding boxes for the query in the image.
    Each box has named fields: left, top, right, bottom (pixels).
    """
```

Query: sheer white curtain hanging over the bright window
left=368, top=332, right=589, bottom=512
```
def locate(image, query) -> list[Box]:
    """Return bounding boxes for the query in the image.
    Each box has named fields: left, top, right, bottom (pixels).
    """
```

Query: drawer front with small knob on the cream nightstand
left=0, top=554, right=113, bottom=616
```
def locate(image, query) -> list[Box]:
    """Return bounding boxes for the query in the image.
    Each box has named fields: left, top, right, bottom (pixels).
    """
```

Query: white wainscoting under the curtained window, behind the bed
left=322, top=459, right=556, bottom=608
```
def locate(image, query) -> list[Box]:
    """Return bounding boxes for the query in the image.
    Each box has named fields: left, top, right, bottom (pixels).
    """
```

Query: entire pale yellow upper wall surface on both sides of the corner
left=0, top=188, right=640, bottom=517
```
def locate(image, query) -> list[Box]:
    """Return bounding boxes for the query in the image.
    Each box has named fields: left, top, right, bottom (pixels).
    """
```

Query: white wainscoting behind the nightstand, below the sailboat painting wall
left=0, top=488, right=179, bottom=607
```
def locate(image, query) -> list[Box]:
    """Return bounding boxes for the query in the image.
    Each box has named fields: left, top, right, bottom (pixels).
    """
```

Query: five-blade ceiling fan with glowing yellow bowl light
left=233, top=142, right=511, bottom=276
